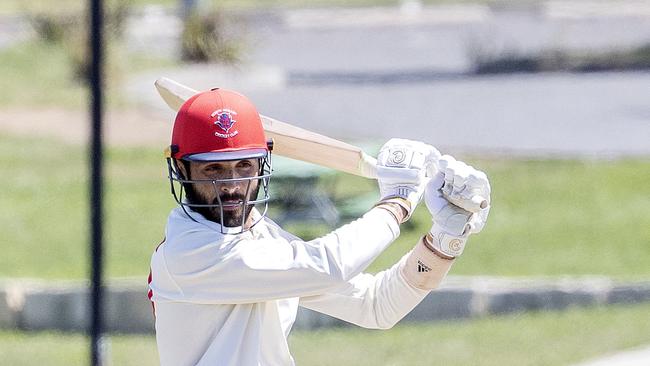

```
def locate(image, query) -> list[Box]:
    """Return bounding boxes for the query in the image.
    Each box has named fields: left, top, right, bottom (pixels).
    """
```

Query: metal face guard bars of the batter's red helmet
left=167, top=152, right=273, bottom=234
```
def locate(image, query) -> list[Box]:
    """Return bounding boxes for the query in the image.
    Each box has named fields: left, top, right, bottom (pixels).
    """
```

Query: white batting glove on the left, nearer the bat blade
left=377, top=139, right=440, bottom=219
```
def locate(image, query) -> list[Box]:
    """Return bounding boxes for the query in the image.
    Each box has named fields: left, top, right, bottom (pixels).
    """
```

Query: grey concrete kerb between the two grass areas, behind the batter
left=0, top=276, right=650, bottom=333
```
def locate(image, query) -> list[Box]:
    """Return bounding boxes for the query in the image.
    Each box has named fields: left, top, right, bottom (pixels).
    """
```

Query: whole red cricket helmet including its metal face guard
left=167, top=88, right=273, bottom=233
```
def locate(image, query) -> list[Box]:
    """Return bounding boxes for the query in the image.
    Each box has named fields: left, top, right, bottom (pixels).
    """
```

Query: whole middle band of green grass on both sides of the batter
left=0, top=136, right=650, bottom=278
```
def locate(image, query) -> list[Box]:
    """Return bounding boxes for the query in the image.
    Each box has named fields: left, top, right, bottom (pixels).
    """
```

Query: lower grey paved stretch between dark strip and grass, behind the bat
left=131, top=67, right=650, bottom=158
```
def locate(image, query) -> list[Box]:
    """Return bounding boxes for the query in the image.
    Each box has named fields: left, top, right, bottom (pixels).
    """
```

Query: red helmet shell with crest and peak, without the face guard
left=170, top=88, right=269, bottom=161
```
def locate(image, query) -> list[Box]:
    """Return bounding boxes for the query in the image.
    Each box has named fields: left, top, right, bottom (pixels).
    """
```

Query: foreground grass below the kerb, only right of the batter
left=290, top=305, right=650, bottom=366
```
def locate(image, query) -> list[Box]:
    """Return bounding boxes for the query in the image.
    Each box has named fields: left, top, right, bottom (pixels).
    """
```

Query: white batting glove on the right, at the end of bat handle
left=424, top=155, right=490, bottom=257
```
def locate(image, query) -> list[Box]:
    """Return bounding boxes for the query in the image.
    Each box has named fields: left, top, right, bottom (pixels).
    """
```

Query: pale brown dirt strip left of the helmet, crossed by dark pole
left=0, top=108, right=173, bottom=149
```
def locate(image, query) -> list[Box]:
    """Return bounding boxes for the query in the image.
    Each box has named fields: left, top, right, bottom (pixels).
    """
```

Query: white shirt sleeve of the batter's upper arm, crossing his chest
left=150, top=209, right=399, bottom=304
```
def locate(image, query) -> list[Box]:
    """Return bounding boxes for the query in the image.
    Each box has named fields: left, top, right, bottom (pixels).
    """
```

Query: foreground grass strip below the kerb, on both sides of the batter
left=0, top=304, right=650, bottom=366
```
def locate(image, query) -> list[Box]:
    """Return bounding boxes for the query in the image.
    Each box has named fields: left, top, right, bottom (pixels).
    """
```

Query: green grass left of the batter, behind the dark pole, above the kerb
left=0, top=136, right=174, bottom=278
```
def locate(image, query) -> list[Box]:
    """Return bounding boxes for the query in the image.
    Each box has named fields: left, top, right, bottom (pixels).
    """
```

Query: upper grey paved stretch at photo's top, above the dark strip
left=249, top=1, right=650, bottom=72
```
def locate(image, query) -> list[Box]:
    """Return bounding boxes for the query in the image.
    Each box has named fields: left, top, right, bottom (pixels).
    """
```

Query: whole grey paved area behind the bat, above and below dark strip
left=129, top=1, right=650, bottom=158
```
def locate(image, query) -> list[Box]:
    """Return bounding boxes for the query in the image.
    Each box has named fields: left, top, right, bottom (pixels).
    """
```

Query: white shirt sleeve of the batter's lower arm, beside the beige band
left=300, top=246, right=452, bottom=329
